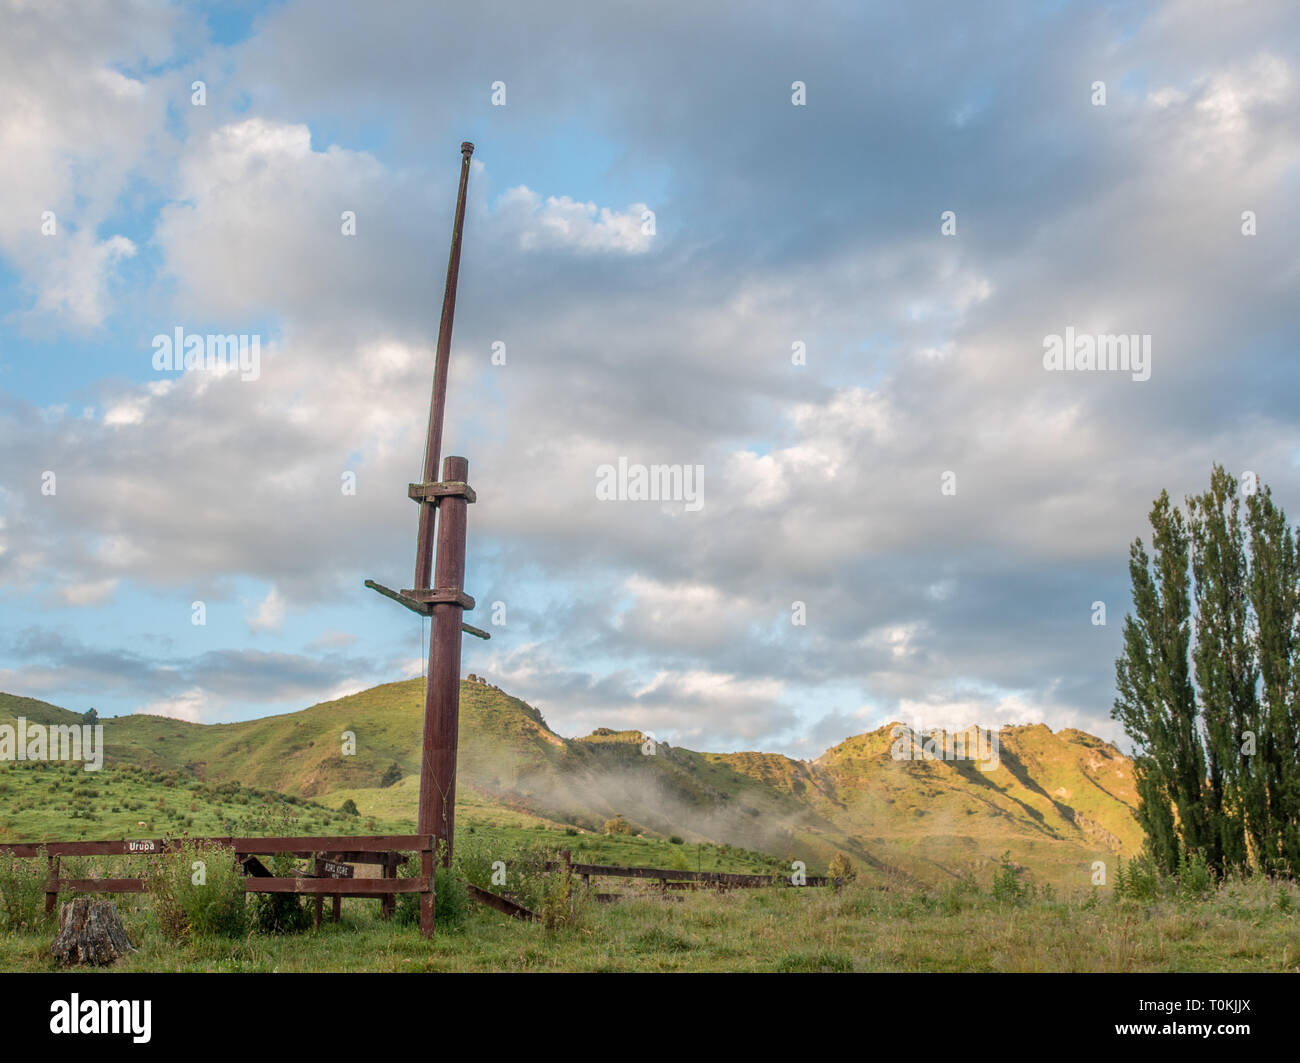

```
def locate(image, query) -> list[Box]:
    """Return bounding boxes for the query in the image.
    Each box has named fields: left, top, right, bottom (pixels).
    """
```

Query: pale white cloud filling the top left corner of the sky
left=0, top=3, right=176, bottom=331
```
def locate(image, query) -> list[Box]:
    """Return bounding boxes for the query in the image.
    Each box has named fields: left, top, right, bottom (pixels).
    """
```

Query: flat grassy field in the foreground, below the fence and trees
left=0, top=881, right=1300, bottom=972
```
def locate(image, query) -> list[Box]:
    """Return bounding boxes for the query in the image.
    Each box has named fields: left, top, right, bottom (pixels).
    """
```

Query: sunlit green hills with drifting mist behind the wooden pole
left=0, top=680, right=1141, bottom=886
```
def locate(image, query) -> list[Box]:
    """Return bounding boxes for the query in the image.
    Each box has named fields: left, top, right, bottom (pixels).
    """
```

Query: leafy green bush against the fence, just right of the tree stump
left=143, top=842, right=248, bottom=941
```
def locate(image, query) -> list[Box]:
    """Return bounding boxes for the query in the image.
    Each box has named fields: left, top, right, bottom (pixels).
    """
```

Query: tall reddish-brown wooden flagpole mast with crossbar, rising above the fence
left=365, top=140, right=489, bottom=936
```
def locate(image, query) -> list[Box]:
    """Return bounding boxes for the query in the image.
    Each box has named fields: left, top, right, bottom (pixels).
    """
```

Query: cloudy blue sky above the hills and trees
left=0, top=3, right=1300, bottom=756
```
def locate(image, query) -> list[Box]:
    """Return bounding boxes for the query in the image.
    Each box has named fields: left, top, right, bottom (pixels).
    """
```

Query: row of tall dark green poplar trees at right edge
left=1112, top=465, right=1300, bottom=873
